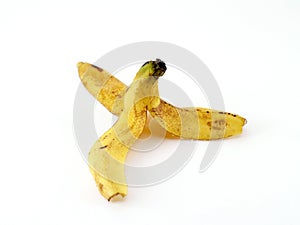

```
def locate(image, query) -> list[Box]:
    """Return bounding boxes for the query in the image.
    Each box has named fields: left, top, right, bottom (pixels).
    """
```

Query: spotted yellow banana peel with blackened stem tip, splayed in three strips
left=77, top=60, right=247, bottom=200
